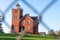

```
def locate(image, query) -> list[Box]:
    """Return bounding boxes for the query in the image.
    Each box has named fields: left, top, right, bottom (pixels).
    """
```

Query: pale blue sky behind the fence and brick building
left=0, top=0, right=60, bottom=33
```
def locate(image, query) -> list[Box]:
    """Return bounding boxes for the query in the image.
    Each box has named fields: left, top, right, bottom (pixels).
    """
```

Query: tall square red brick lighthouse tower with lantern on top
left=11, top=3, right=23, bottom=33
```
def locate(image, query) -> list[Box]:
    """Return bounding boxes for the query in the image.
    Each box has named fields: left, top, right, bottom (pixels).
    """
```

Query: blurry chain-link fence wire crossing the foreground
left=0, top=0, right=60, bottom=40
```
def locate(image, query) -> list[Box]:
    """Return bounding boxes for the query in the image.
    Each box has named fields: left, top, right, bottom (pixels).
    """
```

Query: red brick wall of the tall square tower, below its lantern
left=11, top=9, right=22, bottom=33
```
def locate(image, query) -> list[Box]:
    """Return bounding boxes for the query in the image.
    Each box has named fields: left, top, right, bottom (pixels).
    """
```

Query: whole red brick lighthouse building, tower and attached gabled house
left=11, top=4, right=38, bottom=34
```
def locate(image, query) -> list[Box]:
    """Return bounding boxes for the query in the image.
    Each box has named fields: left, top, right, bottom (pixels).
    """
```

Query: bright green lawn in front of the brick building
left=0, top=33, right=59, bottom=40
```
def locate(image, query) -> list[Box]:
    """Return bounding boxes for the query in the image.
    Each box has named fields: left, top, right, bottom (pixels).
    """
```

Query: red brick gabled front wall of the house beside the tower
left=21, top=15, right=33, bottom=33
